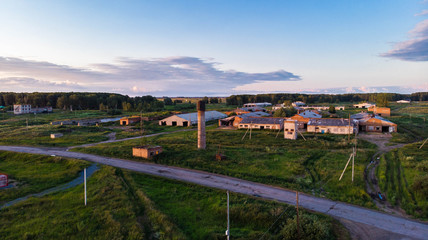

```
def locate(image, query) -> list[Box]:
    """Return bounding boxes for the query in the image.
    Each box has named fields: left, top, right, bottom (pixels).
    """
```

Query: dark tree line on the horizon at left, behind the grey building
left=0, top=92, right=164, bottom=112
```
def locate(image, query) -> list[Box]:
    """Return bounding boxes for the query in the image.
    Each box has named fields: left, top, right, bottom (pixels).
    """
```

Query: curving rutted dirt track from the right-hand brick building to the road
left=358, top=134, right=410, bottom=218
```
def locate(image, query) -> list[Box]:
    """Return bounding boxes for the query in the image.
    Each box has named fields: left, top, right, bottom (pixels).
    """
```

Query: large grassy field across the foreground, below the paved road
left=0, top=154, right=349, bottom=239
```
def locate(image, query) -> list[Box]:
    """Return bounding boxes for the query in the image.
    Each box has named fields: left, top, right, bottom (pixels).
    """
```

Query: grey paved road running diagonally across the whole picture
left=0, top=146, right=428, bottom=239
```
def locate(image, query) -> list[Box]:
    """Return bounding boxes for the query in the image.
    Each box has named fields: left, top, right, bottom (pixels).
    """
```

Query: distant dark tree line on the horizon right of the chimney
left=226, top=92, right=428, bottom=105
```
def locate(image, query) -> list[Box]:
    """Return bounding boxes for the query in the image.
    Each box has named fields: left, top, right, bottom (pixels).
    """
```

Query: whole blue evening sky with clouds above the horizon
left=0, top=0, right=428, bottom=97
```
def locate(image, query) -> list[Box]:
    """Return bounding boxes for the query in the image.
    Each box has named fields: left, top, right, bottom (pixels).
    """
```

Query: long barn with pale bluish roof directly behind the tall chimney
left=159, top=111, right=227, bottom=127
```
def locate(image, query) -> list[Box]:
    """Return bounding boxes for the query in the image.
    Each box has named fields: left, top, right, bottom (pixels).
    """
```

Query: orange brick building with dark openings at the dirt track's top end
left=358, top=116, right=397, bottom=133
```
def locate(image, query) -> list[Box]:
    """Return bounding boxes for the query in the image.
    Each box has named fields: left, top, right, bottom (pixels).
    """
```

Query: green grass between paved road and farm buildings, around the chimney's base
left=74, top=130, right=375, bottom=207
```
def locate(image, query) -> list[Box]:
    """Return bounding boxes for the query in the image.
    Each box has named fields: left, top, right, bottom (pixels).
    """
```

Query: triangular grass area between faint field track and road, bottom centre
left=125, top=172, right=349, bottom=239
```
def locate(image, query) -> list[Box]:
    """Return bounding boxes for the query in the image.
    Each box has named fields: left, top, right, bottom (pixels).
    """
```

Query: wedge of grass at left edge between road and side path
left=0, top=151, right=89, bottom=205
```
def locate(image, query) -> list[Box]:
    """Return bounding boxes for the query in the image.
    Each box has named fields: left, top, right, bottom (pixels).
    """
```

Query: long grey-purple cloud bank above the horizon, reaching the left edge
left=0, top=57, right=301, bottom=96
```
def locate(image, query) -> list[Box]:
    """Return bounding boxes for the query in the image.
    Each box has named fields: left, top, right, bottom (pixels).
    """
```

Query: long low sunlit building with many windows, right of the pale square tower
left=308, top=118, right=355, bottom=134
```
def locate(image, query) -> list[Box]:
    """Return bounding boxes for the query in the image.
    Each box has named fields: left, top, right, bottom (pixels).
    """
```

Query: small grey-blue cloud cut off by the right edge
left=381, top=19, right=428, bottom=61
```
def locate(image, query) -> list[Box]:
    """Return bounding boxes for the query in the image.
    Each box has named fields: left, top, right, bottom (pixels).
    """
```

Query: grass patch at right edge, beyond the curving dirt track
left=377, top=142, right=428, bottom=220
